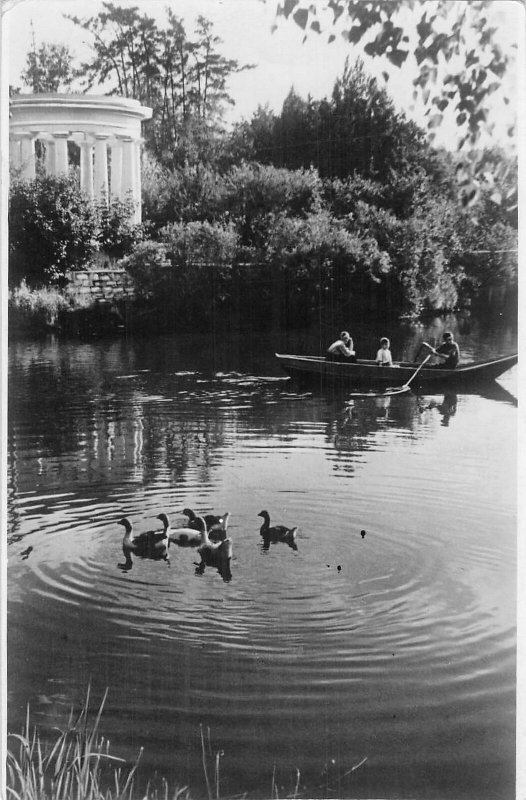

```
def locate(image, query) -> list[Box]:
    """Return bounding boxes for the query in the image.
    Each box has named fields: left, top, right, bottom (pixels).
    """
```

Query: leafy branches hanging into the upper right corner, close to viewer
left=277, top=0, right=514, bottom=202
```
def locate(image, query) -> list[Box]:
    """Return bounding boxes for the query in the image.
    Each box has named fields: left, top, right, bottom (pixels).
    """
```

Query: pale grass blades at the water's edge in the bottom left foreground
left=6, top=688, right=310, bottom=800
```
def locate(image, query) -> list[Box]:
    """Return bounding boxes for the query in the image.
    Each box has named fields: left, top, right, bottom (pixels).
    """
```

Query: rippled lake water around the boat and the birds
left=7, top=318, right=517, bottom=800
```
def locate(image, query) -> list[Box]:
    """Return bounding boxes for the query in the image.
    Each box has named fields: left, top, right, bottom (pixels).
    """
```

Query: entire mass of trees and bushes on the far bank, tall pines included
left=10, top=3, right=517, bottom=334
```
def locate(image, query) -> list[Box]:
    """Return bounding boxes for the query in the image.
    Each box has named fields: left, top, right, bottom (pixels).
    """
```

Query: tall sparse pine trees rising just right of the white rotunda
left=67, top=2, right=254, bottom=165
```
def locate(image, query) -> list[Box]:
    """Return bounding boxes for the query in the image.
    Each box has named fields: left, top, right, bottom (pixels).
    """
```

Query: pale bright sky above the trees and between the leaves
left=8, top=0, right=526, bottom=152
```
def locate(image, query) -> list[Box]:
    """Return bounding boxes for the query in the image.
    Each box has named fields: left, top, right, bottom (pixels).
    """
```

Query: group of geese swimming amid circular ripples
left=117, top=508, right=298, bottom=580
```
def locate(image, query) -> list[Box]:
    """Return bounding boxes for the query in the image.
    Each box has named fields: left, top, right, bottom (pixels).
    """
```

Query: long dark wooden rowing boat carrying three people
left=276, top=353, right=519, bottom=387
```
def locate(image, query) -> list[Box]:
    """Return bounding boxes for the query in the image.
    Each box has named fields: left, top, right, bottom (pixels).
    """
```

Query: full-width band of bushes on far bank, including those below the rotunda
left=10, top=152, right=517, bottom=326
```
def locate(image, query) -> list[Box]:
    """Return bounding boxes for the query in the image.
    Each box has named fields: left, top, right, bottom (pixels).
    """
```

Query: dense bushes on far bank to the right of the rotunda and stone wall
left=129, top=148, right=516, bottom=324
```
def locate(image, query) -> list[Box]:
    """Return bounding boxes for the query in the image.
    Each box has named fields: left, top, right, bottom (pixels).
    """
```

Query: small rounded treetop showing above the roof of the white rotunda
left=22, top=37, right=75, bottom=94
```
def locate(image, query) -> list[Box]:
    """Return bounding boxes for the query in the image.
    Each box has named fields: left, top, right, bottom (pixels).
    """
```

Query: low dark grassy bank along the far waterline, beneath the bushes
left=8, top=282, right=517, bottom=339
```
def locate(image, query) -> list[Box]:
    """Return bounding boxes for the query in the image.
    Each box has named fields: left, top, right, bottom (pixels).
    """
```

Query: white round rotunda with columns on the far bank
left=9, top=94, right=152, bottom=222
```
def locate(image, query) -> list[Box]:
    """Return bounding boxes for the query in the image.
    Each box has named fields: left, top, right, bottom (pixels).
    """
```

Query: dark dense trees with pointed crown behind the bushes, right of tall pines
left=248, top=59, right=442, bottom=198
